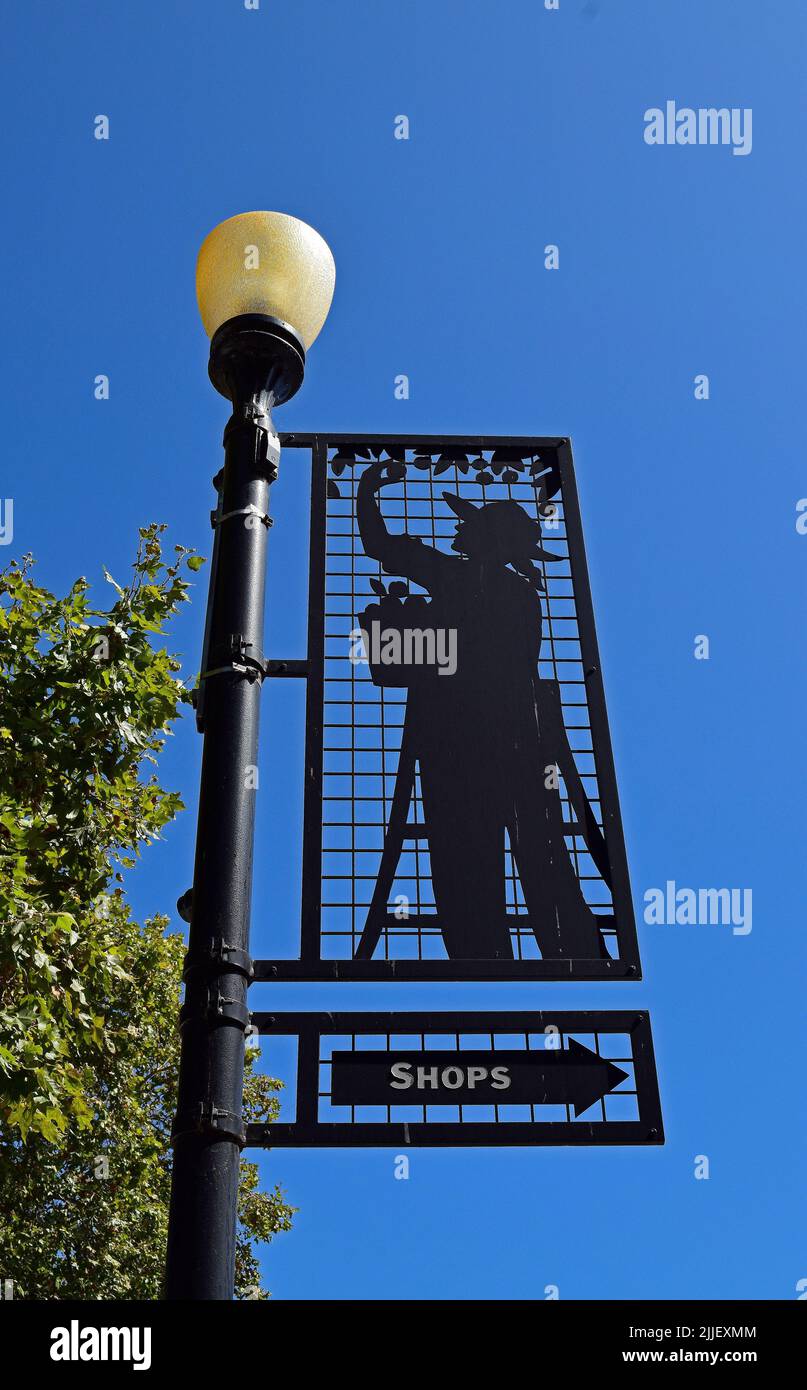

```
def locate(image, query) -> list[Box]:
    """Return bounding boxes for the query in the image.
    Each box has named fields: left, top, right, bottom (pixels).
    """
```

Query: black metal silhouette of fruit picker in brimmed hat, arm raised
left=357, top=463, right=613, bottom=959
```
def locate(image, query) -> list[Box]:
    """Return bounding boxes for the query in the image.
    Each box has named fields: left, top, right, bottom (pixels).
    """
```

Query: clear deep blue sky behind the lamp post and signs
left=0, top=0, right=807, bottom=1298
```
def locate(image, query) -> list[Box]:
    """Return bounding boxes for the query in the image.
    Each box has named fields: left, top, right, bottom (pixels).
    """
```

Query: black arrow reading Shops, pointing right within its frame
left=331, top=1038, right=628, bottom=1115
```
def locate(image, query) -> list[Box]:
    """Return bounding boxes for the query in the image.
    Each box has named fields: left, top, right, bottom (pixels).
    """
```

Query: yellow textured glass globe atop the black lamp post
left=196, top=213, right=336, bottom=350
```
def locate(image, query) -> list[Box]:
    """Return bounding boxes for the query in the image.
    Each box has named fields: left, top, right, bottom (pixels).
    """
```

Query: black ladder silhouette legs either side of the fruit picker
left=353, top=678, right=613, bottom=960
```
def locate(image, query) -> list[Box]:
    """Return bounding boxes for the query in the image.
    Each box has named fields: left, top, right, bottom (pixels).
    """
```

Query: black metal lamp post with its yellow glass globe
left=165, top=213, right=335, bottom=1300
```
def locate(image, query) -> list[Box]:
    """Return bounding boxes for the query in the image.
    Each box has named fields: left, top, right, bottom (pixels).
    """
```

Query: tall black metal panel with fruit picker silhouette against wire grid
left=257, top=435, right=640, bottom=980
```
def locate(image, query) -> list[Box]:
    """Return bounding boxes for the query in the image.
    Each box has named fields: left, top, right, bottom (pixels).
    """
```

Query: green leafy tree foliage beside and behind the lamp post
left=0, top=525, right=292, bottom=1298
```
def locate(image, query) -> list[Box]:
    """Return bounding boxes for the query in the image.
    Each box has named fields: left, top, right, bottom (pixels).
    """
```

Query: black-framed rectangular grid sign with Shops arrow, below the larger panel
left=247, top=1012, right=664, bottom=1148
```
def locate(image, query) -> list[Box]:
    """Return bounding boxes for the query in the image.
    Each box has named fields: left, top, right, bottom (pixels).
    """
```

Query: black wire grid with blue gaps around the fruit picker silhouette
left=322, top=449, right=617, bottom=960
